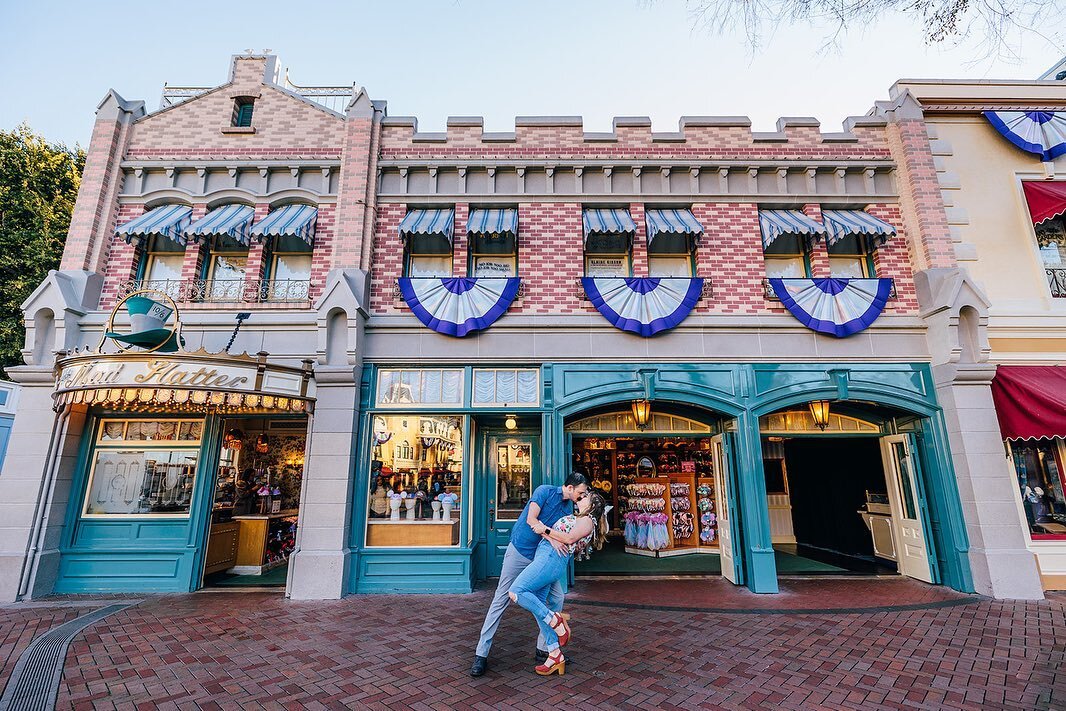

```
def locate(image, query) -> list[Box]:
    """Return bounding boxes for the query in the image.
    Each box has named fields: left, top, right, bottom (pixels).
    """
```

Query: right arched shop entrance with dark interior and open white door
left=761, top=410, right=934, bottom=582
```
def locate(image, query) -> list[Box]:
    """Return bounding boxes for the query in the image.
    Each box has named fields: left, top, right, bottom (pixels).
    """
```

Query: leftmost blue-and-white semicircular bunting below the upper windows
left=397, top=276, right=521, bottom=338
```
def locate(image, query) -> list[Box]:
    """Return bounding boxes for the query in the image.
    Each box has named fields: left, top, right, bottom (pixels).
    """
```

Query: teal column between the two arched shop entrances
left=733, top=413, right=778, bottom=593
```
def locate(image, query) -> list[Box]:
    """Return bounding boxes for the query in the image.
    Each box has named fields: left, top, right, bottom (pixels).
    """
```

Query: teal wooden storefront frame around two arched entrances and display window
left=349, top=362, right=973, bottom=593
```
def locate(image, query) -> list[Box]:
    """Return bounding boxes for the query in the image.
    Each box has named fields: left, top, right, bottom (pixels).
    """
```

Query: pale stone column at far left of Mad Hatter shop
left=0, top=375, right=85, bottom=602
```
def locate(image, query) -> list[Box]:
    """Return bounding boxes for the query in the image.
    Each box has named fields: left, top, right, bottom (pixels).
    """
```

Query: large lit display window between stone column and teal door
left=367, top=414, right=465, bottom=548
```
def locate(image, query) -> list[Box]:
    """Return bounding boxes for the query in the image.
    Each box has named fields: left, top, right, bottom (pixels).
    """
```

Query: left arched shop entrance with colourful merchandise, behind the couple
left=567, top=411, right=742, bottom=584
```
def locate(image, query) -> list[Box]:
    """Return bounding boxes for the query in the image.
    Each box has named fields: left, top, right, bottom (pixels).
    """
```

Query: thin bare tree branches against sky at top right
left=687, top=0, right=1066, bottom=58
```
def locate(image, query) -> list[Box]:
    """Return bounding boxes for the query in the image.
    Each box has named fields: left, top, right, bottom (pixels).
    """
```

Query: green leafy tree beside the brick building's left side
left=0, top=124, right=85, bottom=377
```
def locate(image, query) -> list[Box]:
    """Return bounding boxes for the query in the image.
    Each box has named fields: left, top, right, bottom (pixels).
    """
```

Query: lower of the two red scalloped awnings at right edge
left=992, top=366, right=1066, bottom=439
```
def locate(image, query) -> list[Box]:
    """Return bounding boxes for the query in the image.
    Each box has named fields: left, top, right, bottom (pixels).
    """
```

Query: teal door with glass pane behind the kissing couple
left=485, top=435, right=542, bottom=578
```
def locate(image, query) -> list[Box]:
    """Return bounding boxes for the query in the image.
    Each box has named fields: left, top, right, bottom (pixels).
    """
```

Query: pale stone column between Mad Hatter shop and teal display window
left=289, top=366, right=359, bottom=600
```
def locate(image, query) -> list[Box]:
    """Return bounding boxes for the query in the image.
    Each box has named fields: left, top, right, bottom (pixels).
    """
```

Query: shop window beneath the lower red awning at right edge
left=1011, top=437, right=1066, bottom=539
